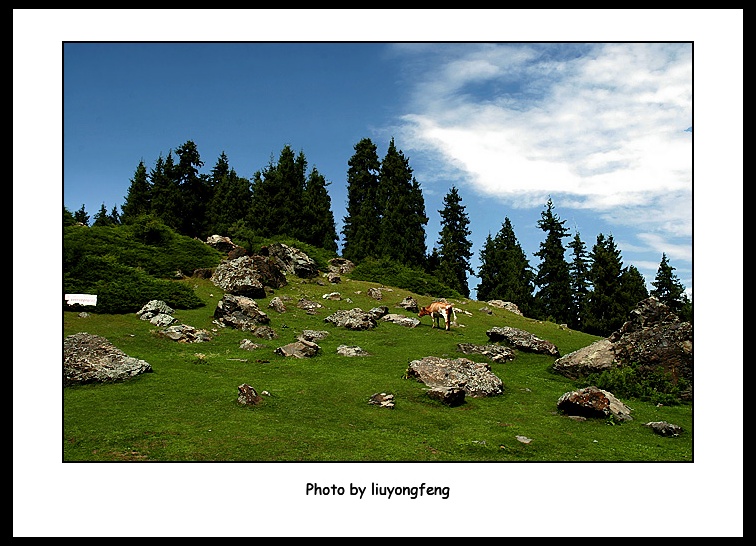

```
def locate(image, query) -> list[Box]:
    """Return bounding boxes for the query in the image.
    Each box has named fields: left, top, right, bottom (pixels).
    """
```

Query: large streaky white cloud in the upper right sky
left=403, top=44, right=692, bottom=235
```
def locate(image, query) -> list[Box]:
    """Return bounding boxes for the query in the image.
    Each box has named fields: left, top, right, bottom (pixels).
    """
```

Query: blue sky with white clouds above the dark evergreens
left=63, top=42, right=693, bottom=300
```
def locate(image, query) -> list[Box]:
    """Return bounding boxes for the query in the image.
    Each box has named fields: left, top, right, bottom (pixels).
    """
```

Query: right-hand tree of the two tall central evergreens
left=377, top=138, right=428, bottom=268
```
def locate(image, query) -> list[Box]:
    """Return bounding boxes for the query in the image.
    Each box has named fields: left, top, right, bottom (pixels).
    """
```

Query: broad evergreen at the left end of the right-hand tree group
left=477, top=217, right=535, bottom=316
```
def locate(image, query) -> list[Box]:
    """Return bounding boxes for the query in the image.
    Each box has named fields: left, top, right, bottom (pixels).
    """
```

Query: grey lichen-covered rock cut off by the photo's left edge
left=63, top=332, right=152, bottom=387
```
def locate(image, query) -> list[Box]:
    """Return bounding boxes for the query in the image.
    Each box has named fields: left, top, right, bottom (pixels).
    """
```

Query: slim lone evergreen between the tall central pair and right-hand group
left=436, top=186, right=474, bottom=298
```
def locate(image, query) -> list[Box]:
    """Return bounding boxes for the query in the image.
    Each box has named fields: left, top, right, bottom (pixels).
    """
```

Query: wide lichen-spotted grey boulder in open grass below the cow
left=405, top=356, right=504, bottom=398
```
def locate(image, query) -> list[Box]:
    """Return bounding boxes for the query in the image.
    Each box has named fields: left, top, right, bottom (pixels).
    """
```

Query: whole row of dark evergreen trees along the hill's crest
left=64, top=138, right=692, bottom=336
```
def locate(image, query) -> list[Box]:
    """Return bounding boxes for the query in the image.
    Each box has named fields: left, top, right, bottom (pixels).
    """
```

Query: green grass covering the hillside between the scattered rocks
left=63, top=277, right=693, bottom=462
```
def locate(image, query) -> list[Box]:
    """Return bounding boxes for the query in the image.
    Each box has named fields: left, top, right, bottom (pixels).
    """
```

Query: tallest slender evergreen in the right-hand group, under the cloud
left=535, top=198, right=572, bottom=323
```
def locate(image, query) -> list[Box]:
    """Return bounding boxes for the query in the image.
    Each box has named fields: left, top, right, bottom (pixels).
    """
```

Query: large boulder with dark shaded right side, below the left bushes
left=210, top=256, right=287, bottom=299
